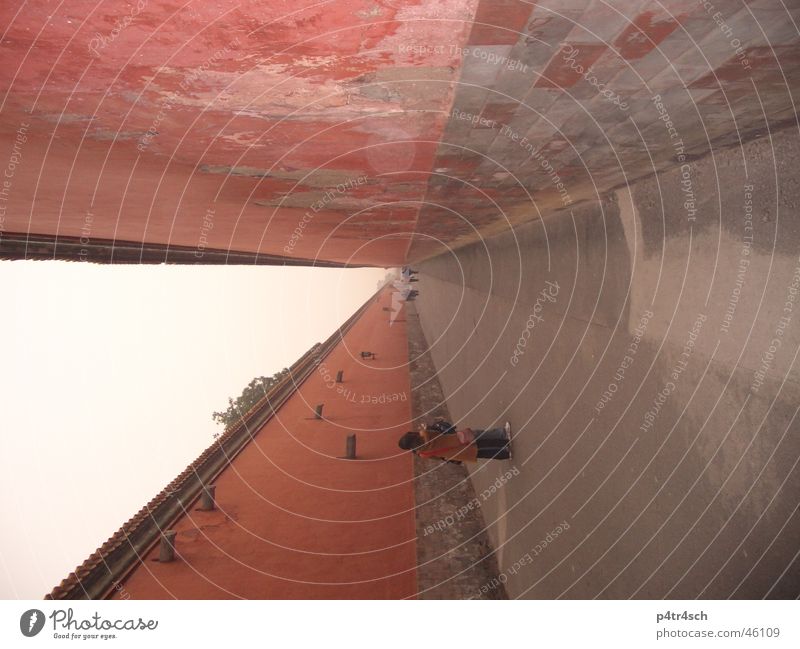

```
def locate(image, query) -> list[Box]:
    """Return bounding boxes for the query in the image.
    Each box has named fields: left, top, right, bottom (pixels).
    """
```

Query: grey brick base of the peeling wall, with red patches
left=410, top=0, right=800, bottom=259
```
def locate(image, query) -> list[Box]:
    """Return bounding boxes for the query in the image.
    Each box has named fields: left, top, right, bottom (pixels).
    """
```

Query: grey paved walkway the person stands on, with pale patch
left=417, top=129, right=800, bottom=598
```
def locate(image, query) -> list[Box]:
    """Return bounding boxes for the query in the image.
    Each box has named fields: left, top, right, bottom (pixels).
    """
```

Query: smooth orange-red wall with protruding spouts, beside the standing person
left=115, top=291, right=416, bottom=599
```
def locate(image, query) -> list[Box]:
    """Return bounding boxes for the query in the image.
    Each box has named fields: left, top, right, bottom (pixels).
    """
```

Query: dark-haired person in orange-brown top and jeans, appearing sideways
left=398, top=419, right=511, bottom=464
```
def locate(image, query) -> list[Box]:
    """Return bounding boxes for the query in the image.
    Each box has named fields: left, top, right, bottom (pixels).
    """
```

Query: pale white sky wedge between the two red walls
left=0, top=261, right=385, bottom=599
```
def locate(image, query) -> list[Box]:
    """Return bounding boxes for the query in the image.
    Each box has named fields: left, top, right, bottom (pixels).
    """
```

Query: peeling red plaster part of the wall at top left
left=0, top=0, right=477, bottom=265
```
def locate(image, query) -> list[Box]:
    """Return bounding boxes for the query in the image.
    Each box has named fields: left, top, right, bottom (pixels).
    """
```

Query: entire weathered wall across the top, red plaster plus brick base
left=0, top=0, right=800, bottom=265
